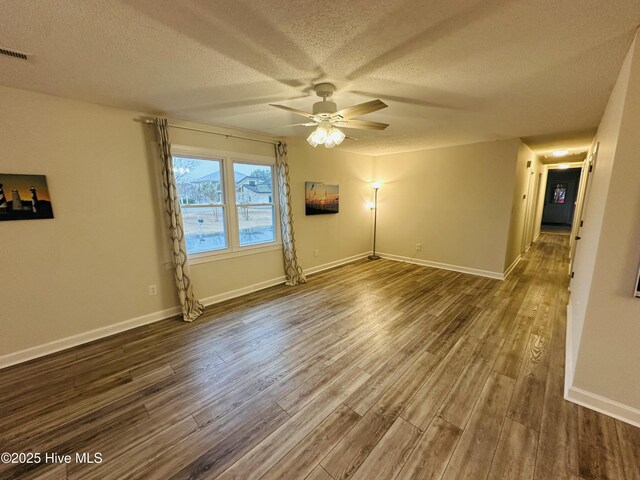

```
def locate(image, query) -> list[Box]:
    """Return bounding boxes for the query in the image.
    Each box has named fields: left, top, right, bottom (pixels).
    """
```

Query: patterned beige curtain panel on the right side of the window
left=276, top=142, right=307, bottom=285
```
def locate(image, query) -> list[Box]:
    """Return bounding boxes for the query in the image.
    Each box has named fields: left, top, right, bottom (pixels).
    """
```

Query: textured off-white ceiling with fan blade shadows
left=0, top=0, right=640, bottom=154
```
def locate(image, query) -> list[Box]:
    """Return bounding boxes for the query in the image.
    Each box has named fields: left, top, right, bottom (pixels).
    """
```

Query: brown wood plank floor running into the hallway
left=0, top=235, right=640, bottom=480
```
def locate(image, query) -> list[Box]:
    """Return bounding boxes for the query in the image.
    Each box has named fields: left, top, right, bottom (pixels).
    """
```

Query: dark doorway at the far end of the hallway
left=542, top=168, right=582, bottom=235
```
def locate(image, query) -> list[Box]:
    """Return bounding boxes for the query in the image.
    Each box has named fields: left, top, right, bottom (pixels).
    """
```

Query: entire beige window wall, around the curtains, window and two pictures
left=0, top=87, right=372, bottom=363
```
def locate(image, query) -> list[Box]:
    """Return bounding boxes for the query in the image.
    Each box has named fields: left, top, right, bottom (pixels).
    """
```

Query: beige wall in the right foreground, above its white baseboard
left=571, top=38, right=640, bottom=408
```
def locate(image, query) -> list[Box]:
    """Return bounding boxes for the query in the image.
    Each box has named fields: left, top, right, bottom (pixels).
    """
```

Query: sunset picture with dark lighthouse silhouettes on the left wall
left=0, top=173, right=53, bottom=221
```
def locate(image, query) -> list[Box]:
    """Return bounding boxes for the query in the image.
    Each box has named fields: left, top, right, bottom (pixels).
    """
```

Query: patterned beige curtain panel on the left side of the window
left=156, top=118, right=204, bottom=322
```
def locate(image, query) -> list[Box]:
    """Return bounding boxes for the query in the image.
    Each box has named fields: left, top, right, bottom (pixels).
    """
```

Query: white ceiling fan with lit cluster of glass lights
left=270, top=83, right=389, bottom=148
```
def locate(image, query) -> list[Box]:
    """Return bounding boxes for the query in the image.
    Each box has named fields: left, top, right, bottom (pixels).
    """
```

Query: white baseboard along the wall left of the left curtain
left=0, top=307, right=181, bottom=369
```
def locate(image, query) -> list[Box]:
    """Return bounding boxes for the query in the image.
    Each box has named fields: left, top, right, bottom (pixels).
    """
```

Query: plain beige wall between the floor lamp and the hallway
left=374, top=139, right=521, bottom=275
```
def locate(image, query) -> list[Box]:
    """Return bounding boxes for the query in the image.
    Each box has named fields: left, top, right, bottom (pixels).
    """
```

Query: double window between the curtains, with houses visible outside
left=172, top=147, right=279, bottom=258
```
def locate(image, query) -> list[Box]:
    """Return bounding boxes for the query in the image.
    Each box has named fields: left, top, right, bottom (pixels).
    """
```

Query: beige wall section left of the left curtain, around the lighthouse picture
left=0, top=87, right=177, bottom=355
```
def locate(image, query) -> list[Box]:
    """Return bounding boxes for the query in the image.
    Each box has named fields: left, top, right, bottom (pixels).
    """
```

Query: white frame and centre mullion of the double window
left=171, top=145, right=282, bottom=265
